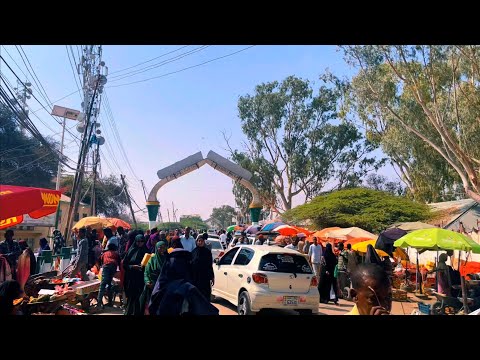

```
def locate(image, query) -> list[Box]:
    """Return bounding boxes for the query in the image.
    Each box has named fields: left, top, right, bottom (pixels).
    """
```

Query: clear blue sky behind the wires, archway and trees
left=1, top=45, right=394, bottom=220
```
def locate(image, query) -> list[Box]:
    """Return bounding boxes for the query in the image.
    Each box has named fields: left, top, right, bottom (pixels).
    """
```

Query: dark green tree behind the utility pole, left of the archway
left=61, top=175, right=129, bottom=217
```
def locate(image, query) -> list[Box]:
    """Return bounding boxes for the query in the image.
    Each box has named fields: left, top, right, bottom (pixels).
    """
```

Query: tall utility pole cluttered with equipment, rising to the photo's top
left=65, top=45, right=108, bottom=241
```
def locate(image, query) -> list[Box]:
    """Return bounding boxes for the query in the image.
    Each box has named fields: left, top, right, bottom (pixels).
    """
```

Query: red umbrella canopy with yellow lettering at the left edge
left=0, top=185, right=61, bottom=229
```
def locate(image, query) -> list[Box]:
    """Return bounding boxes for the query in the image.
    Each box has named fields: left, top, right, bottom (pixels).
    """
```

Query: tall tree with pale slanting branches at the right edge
left=343, top=45, right=480, bottom=201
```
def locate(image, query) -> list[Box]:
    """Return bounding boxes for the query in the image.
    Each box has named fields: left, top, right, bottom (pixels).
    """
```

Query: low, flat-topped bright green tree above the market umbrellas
left=283, top=188, right=432, bottom=233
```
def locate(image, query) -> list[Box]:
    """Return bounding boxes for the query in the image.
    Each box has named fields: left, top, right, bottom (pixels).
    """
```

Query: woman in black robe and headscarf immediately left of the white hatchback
left=192, top=234, right=215, bottom=301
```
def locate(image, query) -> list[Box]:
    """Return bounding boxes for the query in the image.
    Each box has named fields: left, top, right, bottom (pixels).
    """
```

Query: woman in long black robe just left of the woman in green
left=123, top=234, right=148, bottom=315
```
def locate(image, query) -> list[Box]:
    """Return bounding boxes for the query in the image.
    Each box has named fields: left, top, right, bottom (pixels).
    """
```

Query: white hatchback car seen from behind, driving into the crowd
left=212, top=245, right=320, bottom=315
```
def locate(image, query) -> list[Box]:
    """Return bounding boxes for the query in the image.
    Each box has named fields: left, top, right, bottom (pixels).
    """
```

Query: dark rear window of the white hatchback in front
left=258, top=253, right=312, bottom=274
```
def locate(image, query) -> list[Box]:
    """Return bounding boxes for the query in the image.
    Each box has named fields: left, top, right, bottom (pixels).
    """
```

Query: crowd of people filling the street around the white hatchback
left=0, top=227, right=398, bottom=315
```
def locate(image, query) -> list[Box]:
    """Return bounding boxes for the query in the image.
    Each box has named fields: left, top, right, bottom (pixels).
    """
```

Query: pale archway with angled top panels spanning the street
left=147, top=150, right=262, bottom=228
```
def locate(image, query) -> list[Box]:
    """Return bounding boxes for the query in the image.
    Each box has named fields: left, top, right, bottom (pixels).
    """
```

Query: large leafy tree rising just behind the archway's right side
left=231, top=76, right=381, bottom=213
